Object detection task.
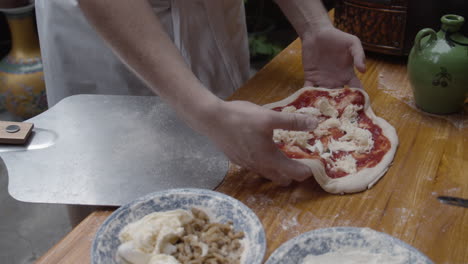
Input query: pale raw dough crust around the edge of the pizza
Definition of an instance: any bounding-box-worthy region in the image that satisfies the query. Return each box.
[264,87,398,193]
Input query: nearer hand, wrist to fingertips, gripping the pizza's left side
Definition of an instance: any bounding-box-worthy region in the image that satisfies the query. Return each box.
[190,101,317,185]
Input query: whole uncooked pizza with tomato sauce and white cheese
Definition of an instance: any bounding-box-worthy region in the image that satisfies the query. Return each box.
[264,87,398,193]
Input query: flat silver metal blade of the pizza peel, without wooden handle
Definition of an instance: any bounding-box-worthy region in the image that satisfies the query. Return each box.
[0,95,228,206]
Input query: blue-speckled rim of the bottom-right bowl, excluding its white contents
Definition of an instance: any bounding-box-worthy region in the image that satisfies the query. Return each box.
[265,227,433,264]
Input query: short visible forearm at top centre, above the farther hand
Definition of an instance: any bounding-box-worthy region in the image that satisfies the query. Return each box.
[275,0,333,39]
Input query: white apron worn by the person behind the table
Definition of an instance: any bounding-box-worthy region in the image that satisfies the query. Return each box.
[36,0,249,106]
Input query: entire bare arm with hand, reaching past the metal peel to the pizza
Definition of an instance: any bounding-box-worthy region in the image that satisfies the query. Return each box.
[79,0,317,184]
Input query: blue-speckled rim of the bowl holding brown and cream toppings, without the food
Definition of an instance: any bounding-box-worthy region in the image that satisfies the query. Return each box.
[91,189,266,264]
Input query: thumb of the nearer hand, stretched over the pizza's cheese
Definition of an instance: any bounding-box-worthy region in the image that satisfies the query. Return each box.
[271,112,318,131]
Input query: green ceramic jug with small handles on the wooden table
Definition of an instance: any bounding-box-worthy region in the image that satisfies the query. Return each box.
[408,15,468,114]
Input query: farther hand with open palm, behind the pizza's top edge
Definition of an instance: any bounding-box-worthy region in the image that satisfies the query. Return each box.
[302,25,366,88]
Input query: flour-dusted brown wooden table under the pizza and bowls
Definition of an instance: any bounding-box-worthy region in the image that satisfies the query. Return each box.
[38,40,468,264]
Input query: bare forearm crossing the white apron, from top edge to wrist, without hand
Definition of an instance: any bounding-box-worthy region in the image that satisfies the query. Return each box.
[79,0,219,118]
